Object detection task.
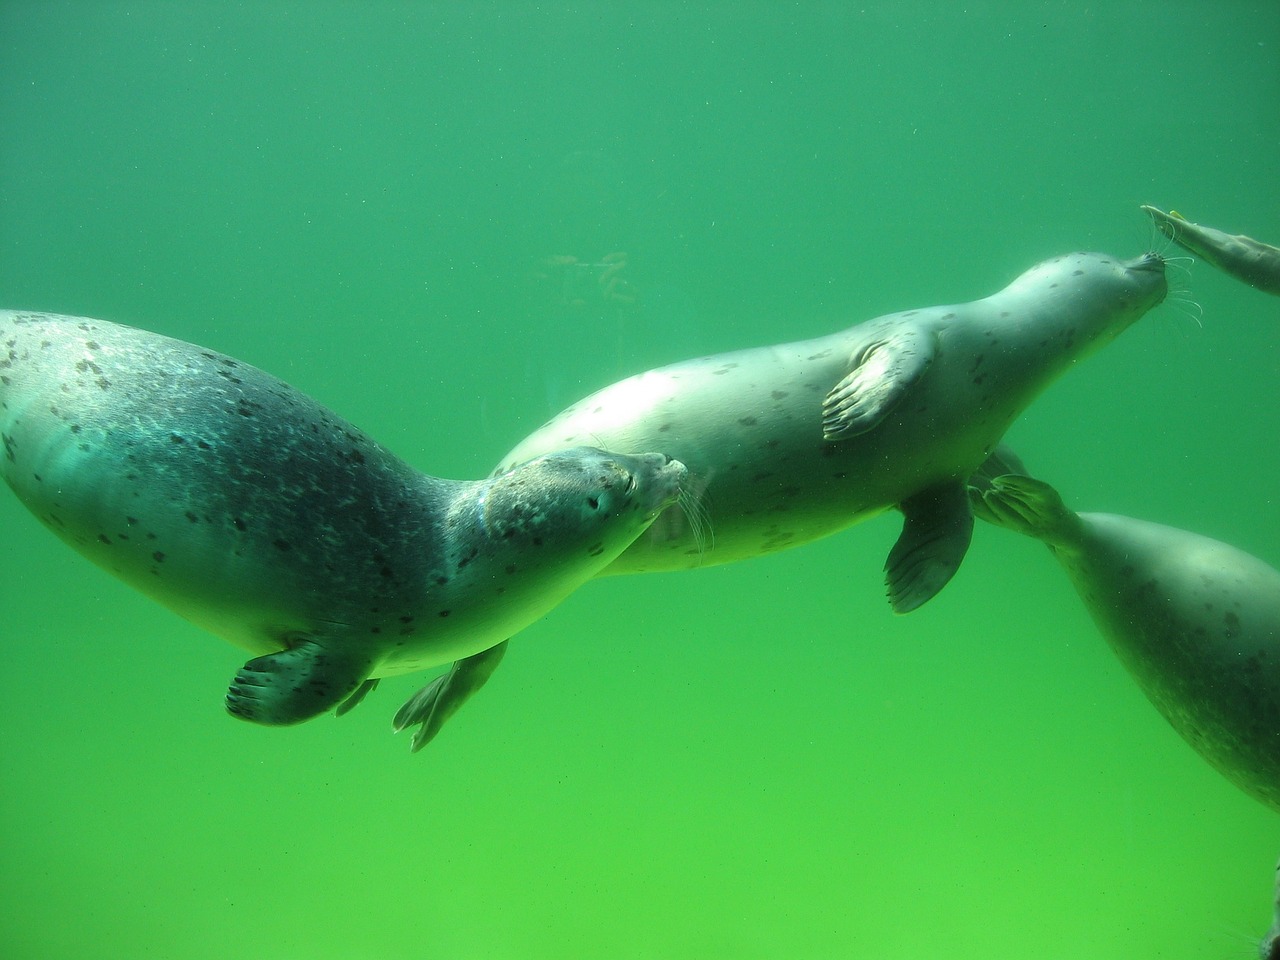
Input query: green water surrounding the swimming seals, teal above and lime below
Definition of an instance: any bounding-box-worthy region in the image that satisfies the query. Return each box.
[0,0,1280,960]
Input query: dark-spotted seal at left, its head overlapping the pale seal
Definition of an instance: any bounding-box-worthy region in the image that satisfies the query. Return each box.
[0,311,685,747]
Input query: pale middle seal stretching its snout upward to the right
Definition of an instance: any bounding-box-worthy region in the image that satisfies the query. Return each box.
[499,253,1166,612]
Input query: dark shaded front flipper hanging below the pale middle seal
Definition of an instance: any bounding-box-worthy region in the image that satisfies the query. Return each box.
[884,480,973,613]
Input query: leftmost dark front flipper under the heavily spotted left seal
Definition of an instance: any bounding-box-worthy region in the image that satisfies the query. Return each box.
[227,640,374,726]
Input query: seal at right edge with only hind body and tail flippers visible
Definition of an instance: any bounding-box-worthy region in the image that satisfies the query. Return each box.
[972,451,1280,810]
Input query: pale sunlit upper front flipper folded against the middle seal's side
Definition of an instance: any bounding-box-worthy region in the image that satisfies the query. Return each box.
[822,326,934,440]
